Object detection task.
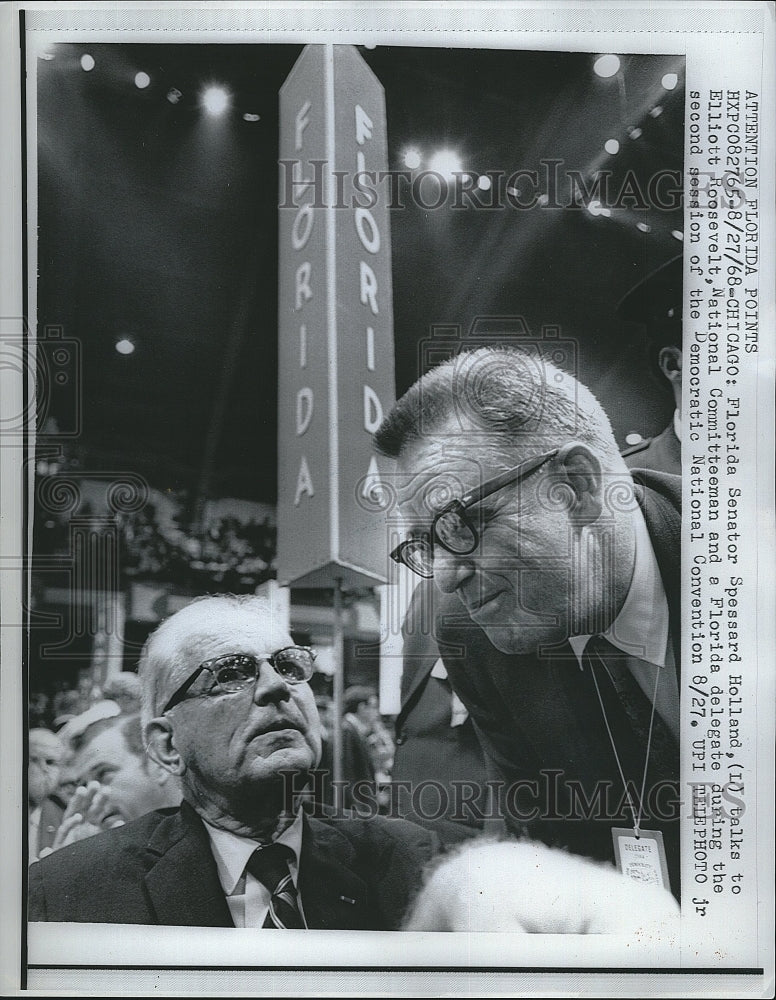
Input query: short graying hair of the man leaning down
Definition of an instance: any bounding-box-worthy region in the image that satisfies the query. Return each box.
[374,347,622,468]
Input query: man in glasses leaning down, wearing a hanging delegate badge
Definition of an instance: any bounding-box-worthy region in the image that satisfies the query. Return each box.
[375,342,681,895]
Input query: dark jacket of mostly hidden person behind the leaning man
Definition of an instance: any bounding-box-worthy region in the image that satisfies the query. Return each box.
[391,580,489,844]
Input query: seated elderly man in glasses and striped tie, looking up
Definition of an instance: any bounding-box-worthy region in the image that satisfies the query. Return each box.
[29,596,437,930]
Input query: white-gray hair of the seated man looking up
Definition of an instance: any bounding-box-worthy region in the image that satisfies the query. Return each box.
[138,594,273,730]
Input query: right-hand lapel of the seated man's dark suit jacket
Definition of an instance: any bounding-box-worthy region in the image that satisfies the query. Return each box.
[299,816,375,930]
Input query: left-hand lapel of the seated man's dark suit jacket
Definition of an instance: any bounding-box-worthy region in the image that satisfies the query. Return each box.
[145,802,234,927]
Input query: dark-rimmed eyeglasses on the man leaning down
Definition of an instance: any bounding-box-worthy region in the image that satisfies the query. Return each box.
[391,448,558,579]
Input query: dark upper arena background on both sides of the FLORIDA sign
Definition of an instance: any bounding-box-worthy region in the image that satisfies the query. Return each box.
[30,43,684,503]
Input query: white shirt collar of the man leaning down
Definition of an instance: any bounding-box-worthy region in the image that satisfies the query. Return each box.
[569,511,669,667]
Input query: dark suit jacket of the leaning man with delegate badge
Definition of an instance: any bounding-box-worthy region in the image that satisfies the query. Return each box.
[437,470,681,889]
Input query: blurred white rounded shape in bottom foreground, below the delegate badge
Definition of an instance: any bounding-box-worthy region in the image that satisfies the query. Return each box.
[403,838,680,941]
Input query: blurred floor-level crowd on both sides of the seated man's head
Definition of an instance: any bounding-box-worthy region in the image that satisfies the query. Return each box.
[28,670,395,863]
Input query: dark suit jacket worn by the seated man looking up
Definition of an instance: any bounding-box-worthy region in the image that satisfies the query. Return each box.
[29,803,438,930]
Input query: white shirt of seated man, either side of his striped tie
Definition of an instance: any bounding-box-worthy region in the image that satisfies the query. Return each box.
[205,810,307,927]
